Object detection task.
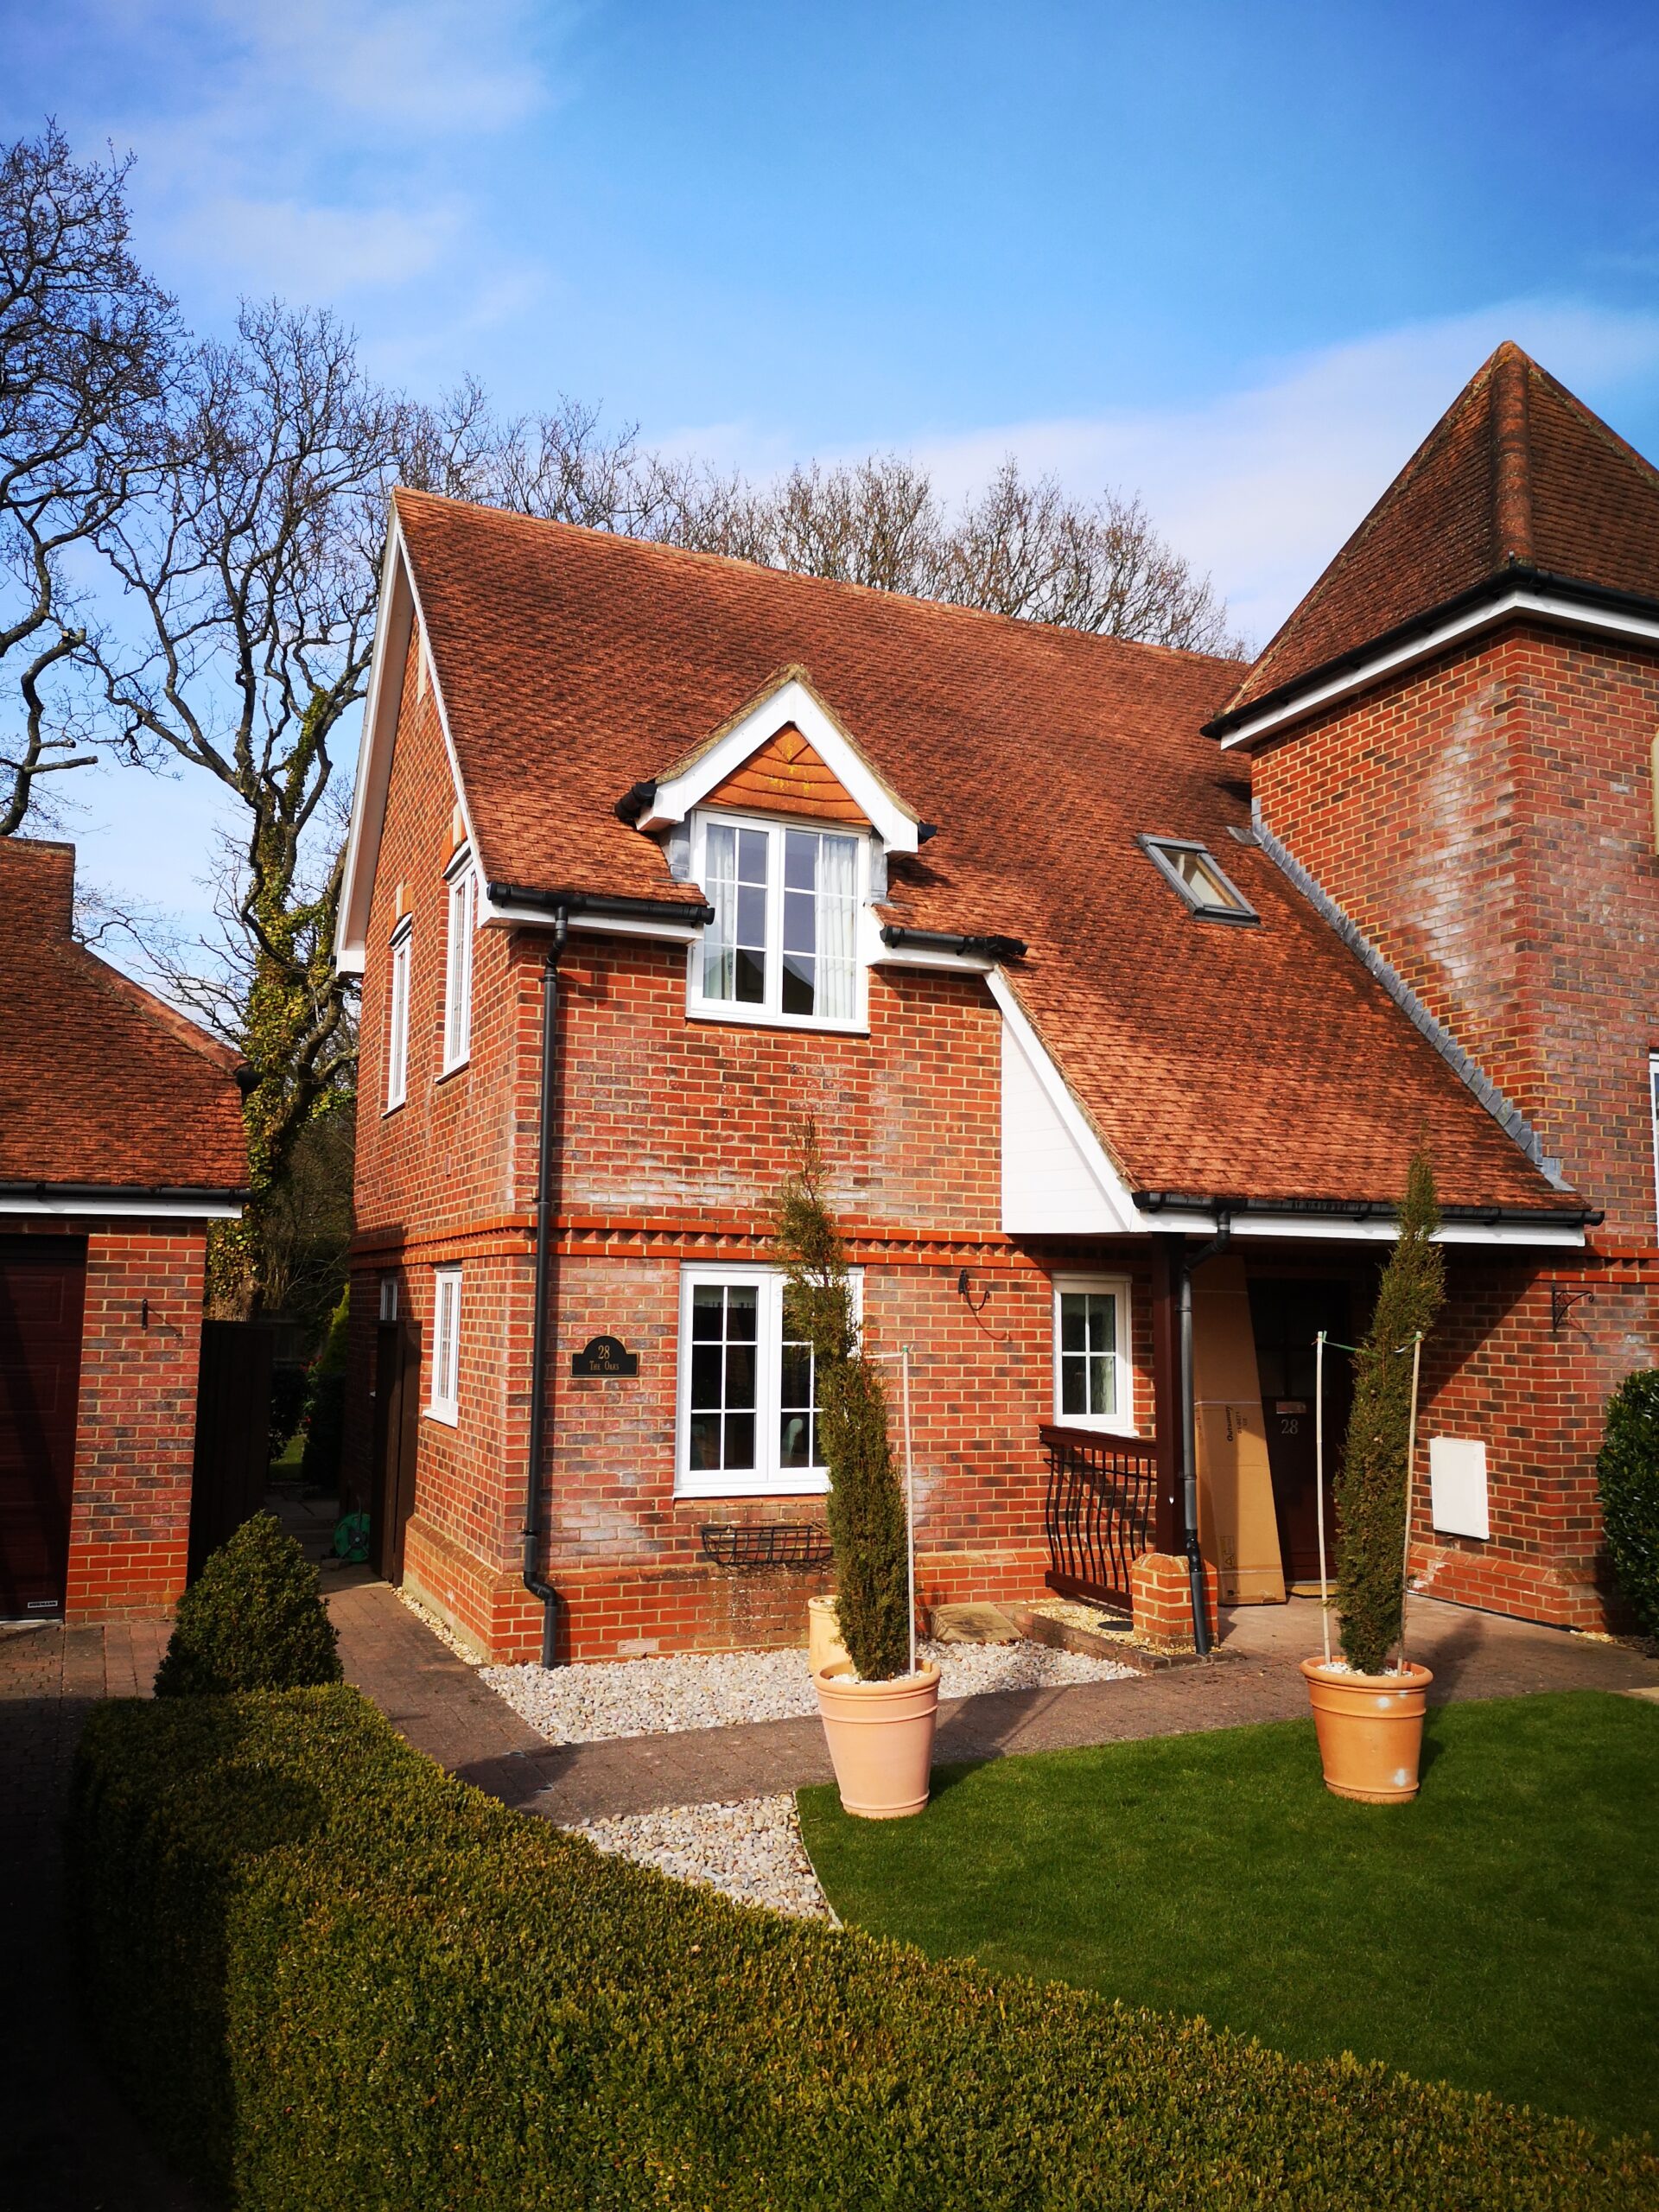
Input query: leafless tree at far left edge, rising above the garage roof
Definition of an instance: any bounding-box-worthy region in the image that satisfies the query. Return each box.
[0,124,175,836]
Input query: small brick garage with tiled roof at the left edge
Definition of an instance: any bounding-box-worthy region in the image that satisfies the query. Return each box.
[0,838,248,1621]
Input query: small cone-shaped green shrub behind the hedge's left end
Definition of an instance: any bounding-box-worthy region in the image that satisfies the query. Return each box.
[155,1513,343,1697]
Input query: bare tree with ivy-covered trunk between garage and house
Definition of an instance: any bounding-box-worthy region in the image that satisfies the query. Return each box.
[98,305,435,1312]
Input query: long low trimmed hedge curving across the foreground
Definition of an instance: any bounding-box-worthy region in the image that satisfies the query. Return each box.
[71,1690,1659,2212]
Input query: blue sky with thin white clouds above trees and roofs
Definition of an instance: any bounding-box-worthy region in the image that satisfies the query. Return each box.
[0,0,1659,925]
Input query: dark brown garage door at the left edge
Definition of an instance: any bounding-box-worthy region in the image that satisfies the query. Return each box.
[0,1236,86,1621]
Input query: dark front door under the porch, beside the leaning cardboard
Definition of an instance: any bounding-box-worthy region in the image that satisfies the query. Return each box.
[1249,1276,1354,1584]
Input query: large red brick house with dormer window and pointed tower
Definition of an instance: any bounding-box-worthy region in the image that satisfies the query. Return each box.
[340,347,1659,1656]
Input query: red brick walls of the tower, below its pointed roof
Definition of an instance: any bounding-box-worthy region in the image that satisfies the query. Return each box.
[1255,626,1659,1626]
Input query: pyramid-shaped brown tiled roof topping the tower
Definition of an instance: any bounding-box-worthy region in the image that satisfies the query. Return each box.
[1225,343,1659,715]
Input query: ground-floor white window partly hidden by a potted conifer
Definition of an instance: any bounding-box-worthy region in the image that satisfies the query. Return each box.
[675,1265,858,1497]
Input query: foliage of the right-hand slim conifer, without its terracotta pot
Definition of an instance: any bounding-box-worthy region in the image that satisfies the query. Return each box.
[1336,1153,1446,1675]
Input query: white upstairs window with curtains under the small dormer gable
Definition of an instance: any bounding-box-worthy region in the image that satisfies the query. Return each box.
[690,814,869,1028]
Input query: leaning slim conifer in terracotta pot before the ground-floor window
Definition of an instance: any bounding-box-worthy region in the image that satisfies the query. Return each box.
[777,1123,938,1821]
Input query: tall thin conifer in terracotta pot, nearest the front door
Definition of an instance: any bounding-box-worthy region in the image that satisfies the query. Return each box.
[1303,1153,1446,1805]
